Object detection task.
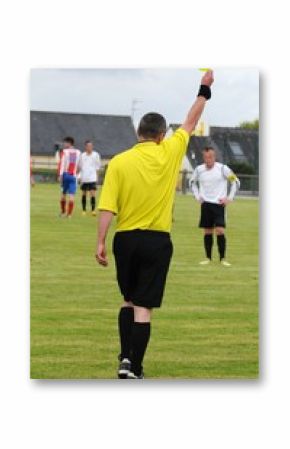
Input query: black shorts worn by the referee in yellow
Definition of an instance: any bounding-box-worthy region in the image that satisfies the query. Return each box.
[113,229,173,309]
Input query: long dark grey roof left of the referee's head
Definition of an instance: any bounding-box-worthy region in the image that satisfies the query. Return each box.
[30,111,137,158]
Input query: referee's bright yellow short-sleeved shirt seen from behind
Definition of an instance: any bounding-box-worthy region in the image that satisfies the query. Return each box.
[98,128,189,232]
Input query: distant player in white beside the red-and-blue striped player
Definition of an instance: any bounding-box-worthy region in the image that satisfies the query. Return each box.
[80,140,101,215]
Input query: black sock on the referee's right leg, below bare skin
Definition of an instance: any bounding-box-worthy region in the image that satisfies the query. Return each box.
[132,323,151,376]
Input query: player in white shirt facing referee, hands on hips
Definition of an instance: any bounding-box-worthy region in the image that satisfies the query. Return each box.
[190,147,240,267]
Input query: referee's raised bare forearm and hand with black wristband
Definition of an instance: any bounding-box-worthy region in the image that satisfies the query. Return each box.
[181,70,214,134]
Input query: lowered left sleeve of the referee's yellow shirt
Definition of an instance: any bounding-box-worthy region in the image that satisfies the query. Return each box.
[98,159,119,214]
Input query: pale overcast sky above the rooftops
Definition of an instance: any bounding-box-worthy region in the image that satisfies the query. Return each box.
[30,68,259,126]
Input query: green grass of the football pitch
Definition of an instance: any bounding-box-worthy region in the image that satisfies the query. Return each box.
[31,184,259,379]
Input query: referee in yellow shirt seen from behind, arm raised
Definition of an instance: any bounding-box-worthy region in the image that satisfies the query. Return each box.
[96,70,213,379]
